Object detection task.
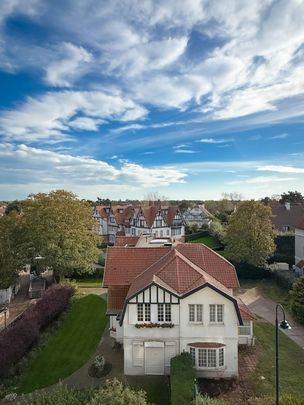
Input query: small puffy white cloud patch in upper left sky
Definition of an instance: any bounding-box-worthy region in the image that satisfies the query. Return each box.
[45,42,93,87]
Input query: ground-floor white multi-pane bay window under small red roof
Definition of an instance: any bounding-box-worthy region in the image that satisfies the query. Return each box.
[190,347,225,368]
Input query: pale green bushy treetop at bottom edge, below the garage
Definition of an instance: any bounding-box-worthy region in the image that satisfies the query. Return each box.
[88,378,148,405]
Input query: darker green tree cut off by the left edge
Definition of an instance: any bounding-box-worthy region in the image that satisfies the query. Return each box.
[0,212,25,289]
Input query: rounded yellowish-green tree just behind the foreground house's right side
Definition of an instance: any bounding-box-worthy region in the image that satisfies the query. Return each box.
[225,200,275,266]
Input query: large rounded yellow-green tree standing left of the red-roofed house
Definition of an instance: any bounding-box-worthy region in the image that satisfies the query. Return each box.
[22,190,99,279]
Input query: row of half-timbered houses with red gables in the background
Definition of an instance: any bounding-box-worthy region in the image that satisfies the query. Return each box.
[94,203,185,243]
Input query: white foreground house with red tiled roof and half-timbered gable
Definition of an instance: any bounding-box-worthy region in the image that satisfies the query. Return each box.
[104,241,255,378]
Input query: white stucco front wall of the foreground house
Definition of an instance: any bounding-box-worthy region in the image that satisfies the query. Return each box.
[123,287,239,378]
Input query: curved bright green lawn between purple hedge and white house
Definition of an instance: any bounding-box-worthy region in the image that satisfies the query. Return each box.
[17,294,107,393]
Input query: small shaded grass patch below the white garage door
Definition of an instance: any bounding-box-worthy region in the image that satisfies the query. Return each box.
[127,376,170,405]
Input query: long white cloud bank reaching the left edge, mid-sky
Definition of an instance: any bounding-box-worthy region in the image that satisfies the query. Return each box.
[0,91,146,142]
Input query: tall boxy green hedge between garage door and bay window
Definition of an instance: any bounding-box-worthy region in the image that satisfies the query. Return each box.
[170,352,196,405]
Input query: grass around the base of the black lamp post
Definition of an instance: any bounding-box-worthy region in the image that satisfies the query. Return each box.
[253,321,304,397]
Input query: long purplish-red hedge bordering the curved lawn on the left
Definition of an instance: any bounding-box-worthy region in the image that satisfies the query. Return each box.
[0,285,73,376]
